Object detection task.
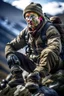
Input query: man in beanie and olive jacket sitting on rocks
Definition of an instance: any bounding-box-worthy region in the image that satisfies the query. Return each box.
[5,2,62,95]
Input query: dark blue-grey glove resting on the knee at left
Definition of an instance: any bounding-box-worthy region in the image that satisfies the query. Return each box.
[7,54,23,73]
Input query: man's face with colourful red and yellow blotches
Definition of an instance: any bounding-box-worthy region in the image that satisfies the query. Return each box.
[25,12,40,30]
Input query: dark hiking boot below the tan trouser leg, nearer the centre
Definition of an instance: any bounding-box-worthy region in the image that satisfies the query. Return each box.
[25,72,40,92]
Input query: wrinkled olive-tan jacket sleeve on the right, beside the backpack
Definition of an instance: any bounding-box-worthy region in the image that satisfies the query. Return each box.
[46,26,62,55]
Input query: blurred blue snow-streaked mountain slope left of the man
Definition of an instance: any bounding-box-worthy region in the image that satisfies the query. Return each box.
[0,1,26,80]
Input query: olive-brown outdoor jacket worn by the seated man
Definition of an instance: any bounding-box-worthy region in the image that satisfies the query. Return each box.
[5,21,62,74]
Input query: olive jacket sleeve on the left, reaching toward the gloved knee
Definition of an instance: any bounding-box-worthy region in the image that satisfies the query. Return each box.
[5,28,26,57]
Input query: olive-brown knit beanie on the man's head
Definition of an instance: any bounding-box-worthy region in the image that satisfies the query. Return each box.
[23,2,43,17]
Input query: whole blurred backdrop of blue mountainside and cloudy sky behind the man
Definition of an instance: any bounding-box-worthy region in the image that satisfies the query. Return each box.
[0,0,64,81]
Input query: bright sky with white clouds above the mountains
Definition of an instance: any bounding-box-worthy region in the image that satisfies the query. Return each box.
[4,0,64,15]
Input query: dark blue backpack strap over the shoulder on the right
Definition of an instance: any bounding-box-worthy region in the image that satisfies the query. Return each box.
[40,21,53,48]
